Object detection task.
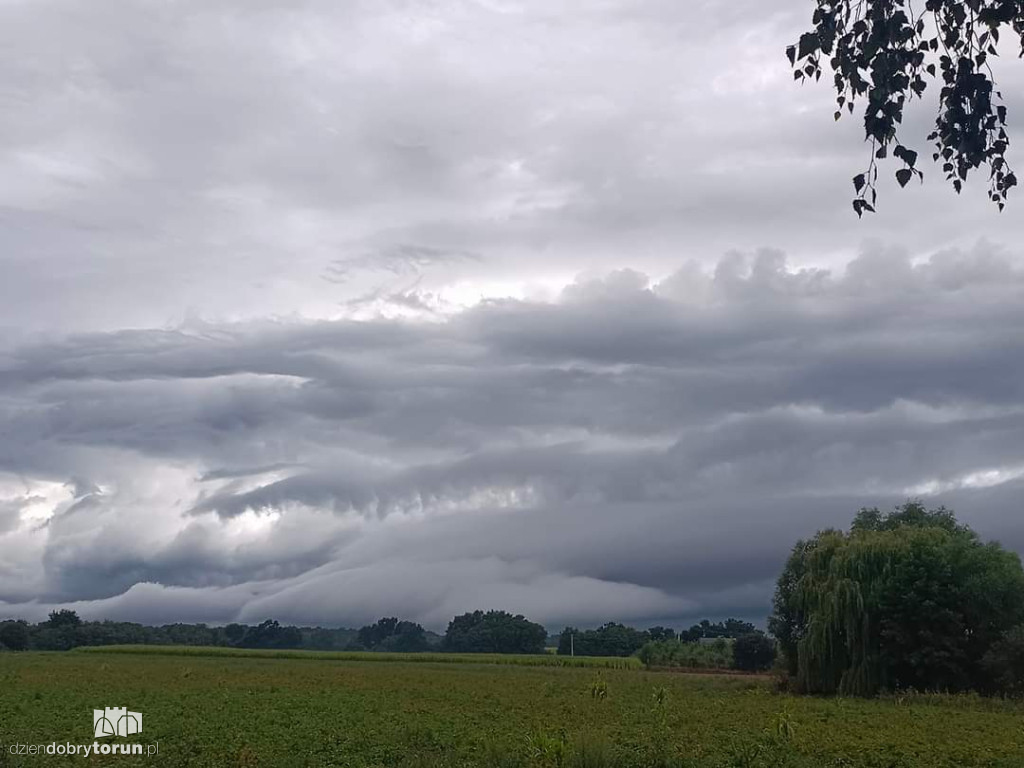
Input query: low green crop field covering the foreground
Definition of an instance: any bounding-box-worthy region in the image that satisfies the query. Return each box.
[0,649,1024,768]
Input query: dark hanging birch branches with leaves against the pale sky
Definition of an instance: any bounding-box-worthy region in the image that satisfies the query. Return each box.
[786,0,1024,211]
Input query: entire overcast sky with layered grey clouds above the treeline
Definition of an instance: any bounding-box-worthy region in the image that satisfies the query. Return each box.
[0,0,1024,630]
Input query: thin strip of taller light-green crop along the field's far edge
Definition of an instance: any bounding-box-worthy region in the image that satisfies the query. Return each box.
[74,645,643,670]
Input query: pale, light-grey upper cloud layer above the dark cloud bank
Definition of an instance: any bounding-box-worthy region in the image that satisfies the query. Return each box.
[0,0,1024,331]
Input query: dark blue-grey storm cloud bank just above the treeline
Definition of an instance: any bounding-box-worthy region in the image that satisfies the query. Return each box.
[0,249,1024,627]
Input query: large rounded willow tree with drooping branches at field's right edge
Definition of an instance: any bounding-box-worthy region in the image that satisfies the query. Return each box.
[769,502,1024,695]
